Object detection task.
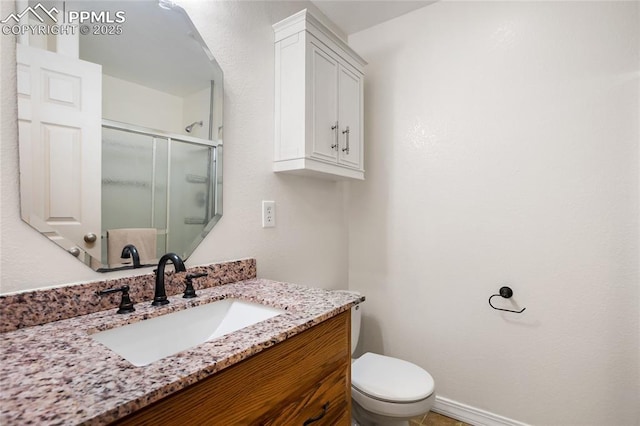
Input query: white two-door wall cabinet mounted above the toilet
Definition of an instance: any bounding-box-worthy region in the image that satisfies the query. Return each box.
[273,10,366,180]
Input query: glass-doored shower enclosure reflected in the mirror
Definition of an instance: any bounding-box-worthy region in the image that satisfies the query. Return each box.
[102,120,222,267]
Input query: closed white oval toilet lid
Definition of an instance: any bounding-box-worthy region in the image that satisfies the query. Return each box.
[351,352,434,402]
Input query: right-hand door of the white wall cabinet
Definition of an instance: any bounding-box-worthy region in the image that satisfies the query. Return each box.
[338,66,362,169]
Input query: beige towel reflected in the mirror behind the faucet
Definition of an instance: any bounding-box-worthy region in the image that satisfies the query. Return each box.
[107,228,158,267]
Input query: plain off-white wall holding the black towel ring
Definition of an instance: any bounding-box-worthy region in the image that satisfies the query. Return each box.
[348,2,640,426]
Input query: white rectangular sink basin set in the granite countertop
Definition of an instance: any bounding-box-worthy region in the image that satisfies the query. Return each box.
[91,299,285,367]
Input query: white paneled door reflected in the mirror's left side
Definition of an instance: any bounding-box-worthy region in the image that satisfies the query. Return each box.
[17,44,102,259]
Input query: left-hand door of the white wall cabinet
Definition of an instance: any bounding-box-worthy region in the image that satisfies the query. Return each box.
[311,44,338,163]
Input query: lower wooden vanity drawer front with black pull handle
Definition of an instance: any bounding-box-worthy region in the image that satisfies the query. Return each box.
[260,370,351,426]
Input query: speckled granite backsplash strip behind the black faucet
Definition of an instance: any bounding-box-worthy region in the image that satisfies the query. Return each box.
[0,259,256,333]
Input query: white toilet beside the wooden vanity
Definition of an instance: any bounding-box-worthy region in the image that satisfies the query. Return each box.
[351,303,436,426]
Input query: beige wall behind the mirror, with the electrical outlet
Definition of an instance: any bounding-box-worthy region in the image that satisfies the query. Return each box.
[0,1,347,293]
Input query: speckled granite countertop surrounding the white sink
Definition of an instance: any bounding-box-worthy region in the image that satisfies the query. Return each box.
[0,279,364,425]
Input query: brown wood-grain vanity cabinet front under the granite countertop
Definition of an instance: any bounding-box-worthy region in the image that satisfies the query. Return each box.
[116,311,351,426]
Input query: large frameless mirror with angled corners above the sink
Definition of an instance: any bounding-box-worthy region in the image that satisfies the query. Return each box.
[16,0,223,272]
